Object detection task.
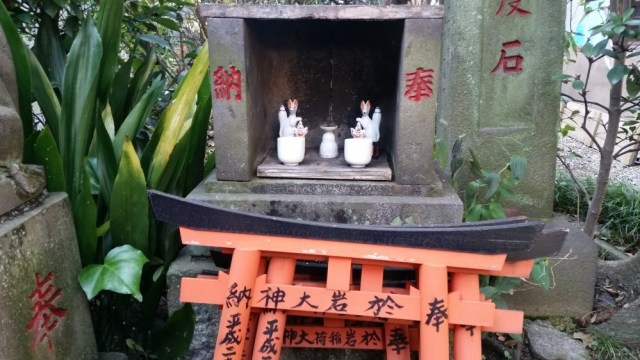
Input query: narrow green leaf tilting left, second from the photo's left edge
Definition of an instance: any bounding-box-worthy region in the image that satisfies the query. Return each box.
[27,50,62,138]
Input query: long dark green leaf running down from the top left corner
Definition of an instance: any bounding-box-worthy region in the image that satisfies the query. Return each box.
[0,2,33,139]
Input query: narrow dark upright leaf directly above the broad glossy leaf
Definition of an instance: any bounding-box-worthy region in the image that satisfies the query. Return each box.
[72,162,98,265]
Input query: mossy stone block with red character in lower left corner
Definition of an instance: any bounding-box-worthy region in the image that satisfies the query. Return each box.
[0,193,98,360]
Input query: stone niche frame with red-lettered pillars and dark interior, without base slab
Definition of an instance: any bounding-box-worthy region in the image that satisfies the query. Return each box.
[208,4,443,185]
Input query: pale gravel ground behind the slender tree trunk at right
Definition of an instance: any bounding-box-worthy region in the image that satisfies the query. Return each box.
[556,137,640,187]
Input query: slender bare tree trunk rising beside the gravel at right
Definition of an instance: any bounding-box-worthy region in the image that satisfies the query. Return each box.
[583,1,627,237]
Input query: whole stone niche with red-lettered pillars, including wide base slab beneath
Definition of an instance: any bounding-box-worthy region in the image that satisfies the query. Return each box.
[195,4,462,224]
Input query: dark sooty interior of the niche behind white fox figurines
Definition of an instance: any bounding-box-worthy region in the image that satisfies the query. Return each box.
[245,19,404,158]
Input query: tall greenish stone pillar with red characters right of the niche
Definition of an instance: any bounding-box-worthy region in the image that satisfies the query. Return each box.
[437,0,566,218]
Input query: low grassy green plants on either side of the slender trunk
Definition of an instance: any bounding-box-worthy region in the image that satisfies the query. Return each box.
[554,171,640,251]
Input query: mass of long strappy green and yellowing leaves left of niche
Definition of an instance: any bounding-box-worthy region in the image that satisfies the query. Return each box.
[0,0,215,359]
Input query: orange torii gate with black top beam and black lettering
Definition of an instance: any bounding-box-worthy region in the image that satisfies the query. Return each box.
[151,193,566,360]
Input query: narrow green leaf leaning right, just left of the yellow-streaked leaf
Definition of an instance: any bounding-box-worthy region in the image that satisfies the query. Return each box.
[113,77,165,161]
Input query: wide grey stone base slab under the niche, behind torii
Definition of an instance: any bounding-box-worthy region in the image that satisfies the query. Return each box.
[187,166,463,225]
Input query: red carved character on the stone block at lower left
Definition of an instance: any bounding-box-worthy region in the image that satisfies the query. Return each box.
[27,273,67,352]
